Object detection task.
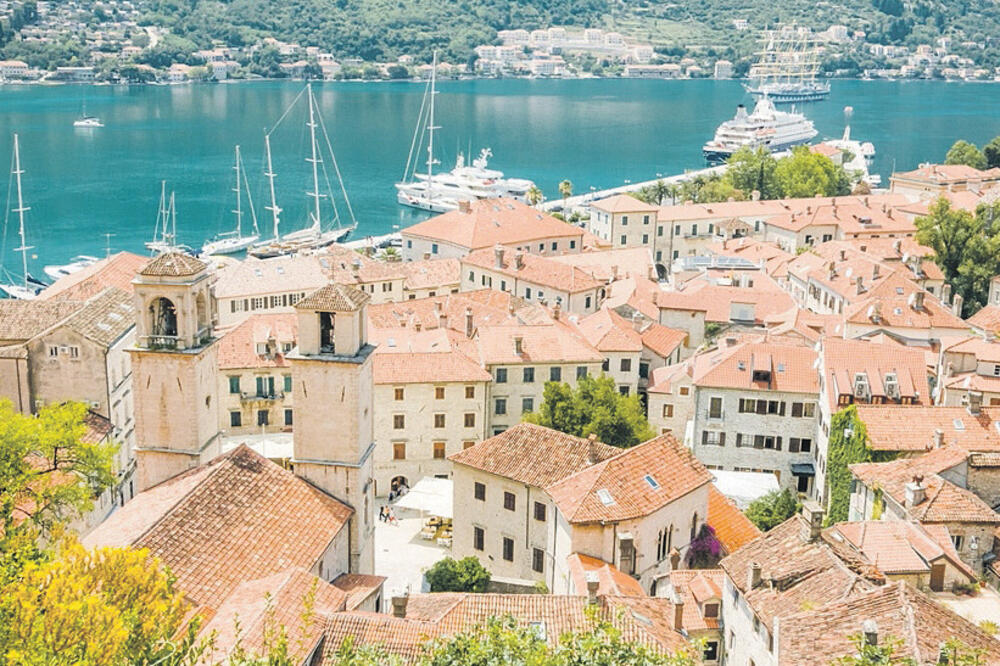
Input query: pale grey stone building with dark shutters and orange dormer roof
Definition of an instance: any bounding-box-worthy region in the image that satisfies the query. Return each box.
[687,339,819,494]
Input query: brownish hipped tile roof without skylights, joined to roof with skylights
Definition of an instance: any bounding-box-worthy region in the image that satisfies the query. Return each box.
[448,423,621,488]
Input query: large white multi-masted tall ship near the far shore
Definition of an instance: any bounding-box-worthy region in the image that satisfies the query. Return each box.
[744,26,830,104]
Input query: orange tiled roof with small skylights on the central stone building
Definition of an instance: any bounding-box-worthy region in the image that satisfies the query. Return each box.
[546,434,712,523]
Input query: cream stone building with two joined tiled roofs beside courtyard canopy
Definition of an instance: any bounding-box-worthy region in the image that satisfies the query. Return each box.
[451,423,711,594]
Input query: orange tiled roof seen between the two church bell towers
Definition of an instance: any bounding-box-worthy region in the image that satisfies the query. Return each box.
[218,312,299,370]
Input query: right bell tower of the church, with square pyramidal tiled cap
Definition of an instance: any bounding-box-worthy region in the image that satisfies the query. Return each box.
[288,284,375,573]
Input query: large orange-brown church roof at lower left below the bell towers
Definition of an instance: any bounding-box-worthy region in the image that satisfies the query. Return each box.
[83,445,353,608]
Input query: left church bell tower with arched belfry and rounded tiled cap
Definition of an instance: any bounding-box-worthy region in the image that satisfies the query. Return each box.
[129,253,220,491]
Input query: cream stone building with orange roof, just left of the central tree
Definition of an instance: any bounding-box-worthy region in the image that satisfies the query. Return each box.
[473,321,604,435]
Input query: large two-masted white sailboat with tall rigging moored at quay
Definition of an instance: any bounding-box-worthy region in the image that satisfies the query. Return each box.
[247,84,358,259]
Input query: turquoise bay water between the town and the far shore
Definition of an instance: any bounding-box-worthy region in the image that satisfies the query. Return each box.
[0,79,1000,276]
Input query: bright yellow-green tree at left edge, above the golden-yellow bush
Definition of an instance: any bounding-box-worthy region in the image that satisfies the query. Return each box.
[0,400,116,536]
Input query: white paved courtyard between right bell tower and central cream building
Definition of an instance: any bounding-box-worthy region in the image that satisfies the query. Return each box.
[375,499,451,598]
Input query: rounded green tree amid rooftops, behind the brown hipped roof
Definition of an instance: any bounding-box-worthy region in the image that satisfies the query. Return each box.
[524,375,655,448]
